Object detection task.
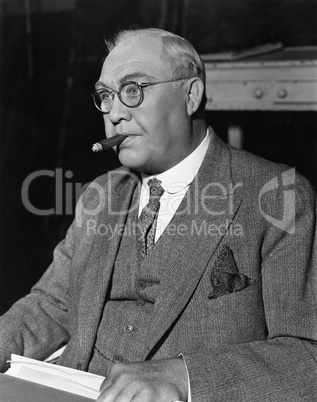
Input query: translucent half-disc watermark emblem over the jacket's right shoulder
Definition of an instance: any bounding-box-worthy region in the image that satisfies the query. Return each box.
[259,168,295,234]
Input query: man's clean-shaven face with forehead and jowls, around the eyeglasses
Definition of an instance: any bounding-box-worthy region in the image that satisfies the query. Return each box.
[96,35,196,174]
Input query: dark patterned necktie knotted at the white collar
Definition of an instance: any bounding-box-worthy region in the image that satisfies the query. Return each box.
[137,177,164,260]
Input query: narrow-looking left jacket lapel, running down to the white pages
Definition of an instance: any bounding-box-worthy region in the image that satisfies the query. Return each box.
[76,171,140,369]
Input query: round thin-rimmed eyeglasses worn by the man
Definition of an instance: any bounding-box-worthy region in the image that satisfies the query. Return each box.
[92,78,186,113]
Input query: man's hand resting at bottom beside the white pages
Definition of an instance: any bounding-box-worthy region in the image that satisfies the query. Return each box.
[97,358,188,402]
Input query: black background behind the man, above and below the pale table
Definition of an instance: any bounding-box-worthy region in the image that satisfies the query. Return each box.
[0,0,317,313]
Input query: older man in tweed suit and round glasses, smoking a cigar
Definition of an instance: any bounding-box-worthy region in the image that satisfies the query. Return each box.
[0,29,317,402]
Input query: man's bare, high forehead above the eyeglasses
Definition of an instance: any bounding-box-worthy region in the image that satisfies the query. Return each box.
[100,35,172,85]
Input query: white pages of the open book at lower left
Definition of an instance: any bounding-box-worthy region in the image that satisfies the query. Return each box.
[5,354,105,400]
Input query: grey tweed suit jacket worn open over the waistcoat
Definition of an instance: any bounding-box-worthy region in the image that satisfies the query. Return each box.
[0,133,317,402]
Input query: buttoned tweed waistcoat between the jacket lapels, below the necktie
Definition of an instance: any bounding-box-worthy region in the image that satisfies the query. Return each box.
[88,192,166,376]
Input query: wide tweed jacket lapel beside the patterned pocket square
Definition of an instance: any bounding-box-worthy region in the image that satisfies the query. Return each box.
[146,133,242,356]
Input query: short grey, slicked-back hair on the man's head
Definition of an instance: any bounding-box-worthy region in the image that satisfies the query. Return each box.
[106,28,206,110]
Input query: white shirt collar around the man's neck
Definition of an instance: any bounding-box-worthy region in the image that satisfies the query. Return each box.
[141,129,210,194]
